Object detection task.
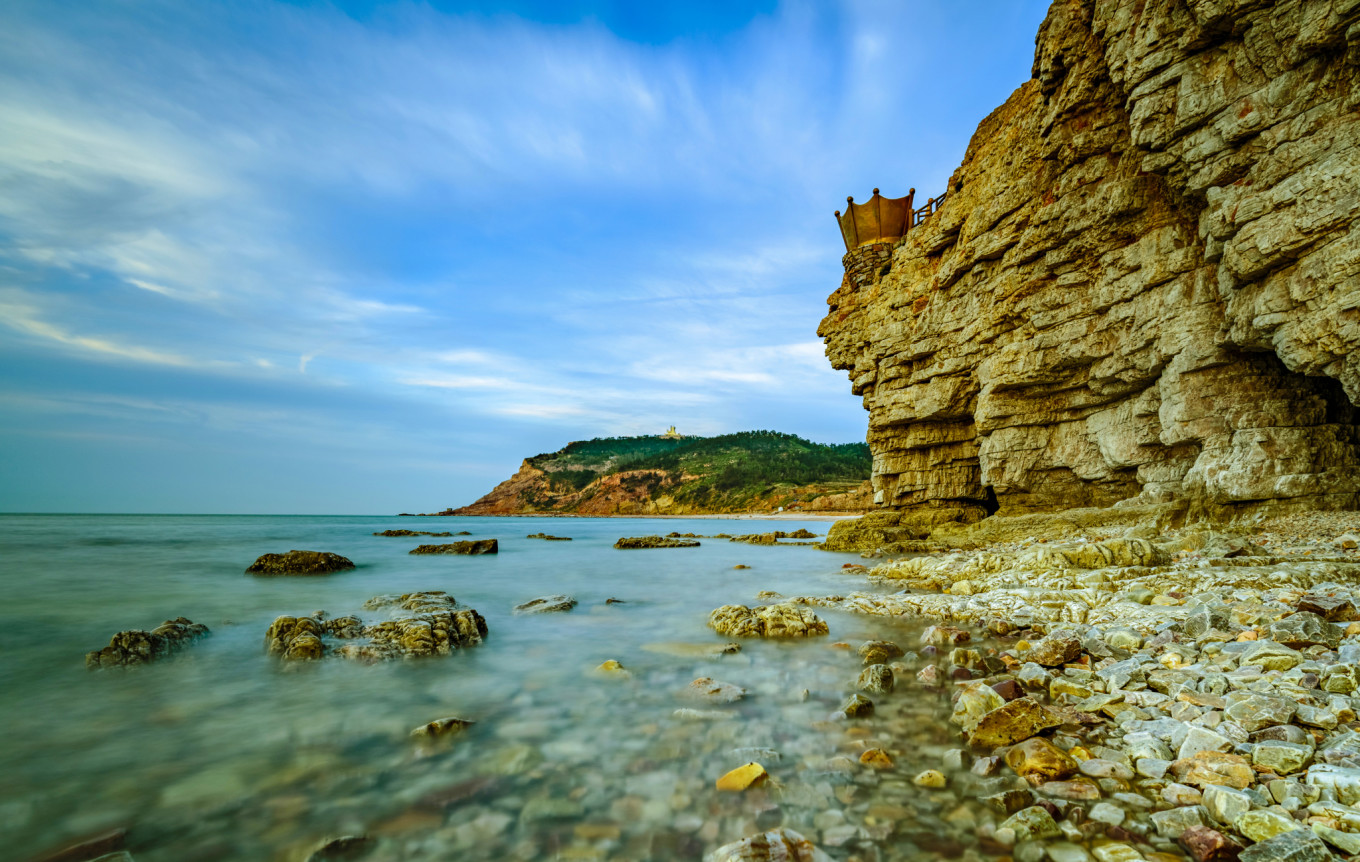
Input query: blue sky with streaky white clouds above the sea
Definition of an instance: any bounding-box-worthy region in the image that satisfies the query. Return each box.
[0,0,1047,514]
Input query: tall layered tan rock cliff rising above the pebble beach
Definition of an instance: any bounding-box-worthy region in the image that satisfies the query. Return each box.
[819,0,1360,528]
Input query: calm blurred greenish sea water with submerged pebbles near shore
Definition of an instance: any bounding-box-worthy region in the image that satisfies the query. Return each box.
[0,515,989,862]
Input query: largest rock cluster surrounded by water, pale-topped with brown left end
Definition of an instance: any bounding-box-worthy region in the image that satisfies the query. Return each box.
[264,590,487,662]
